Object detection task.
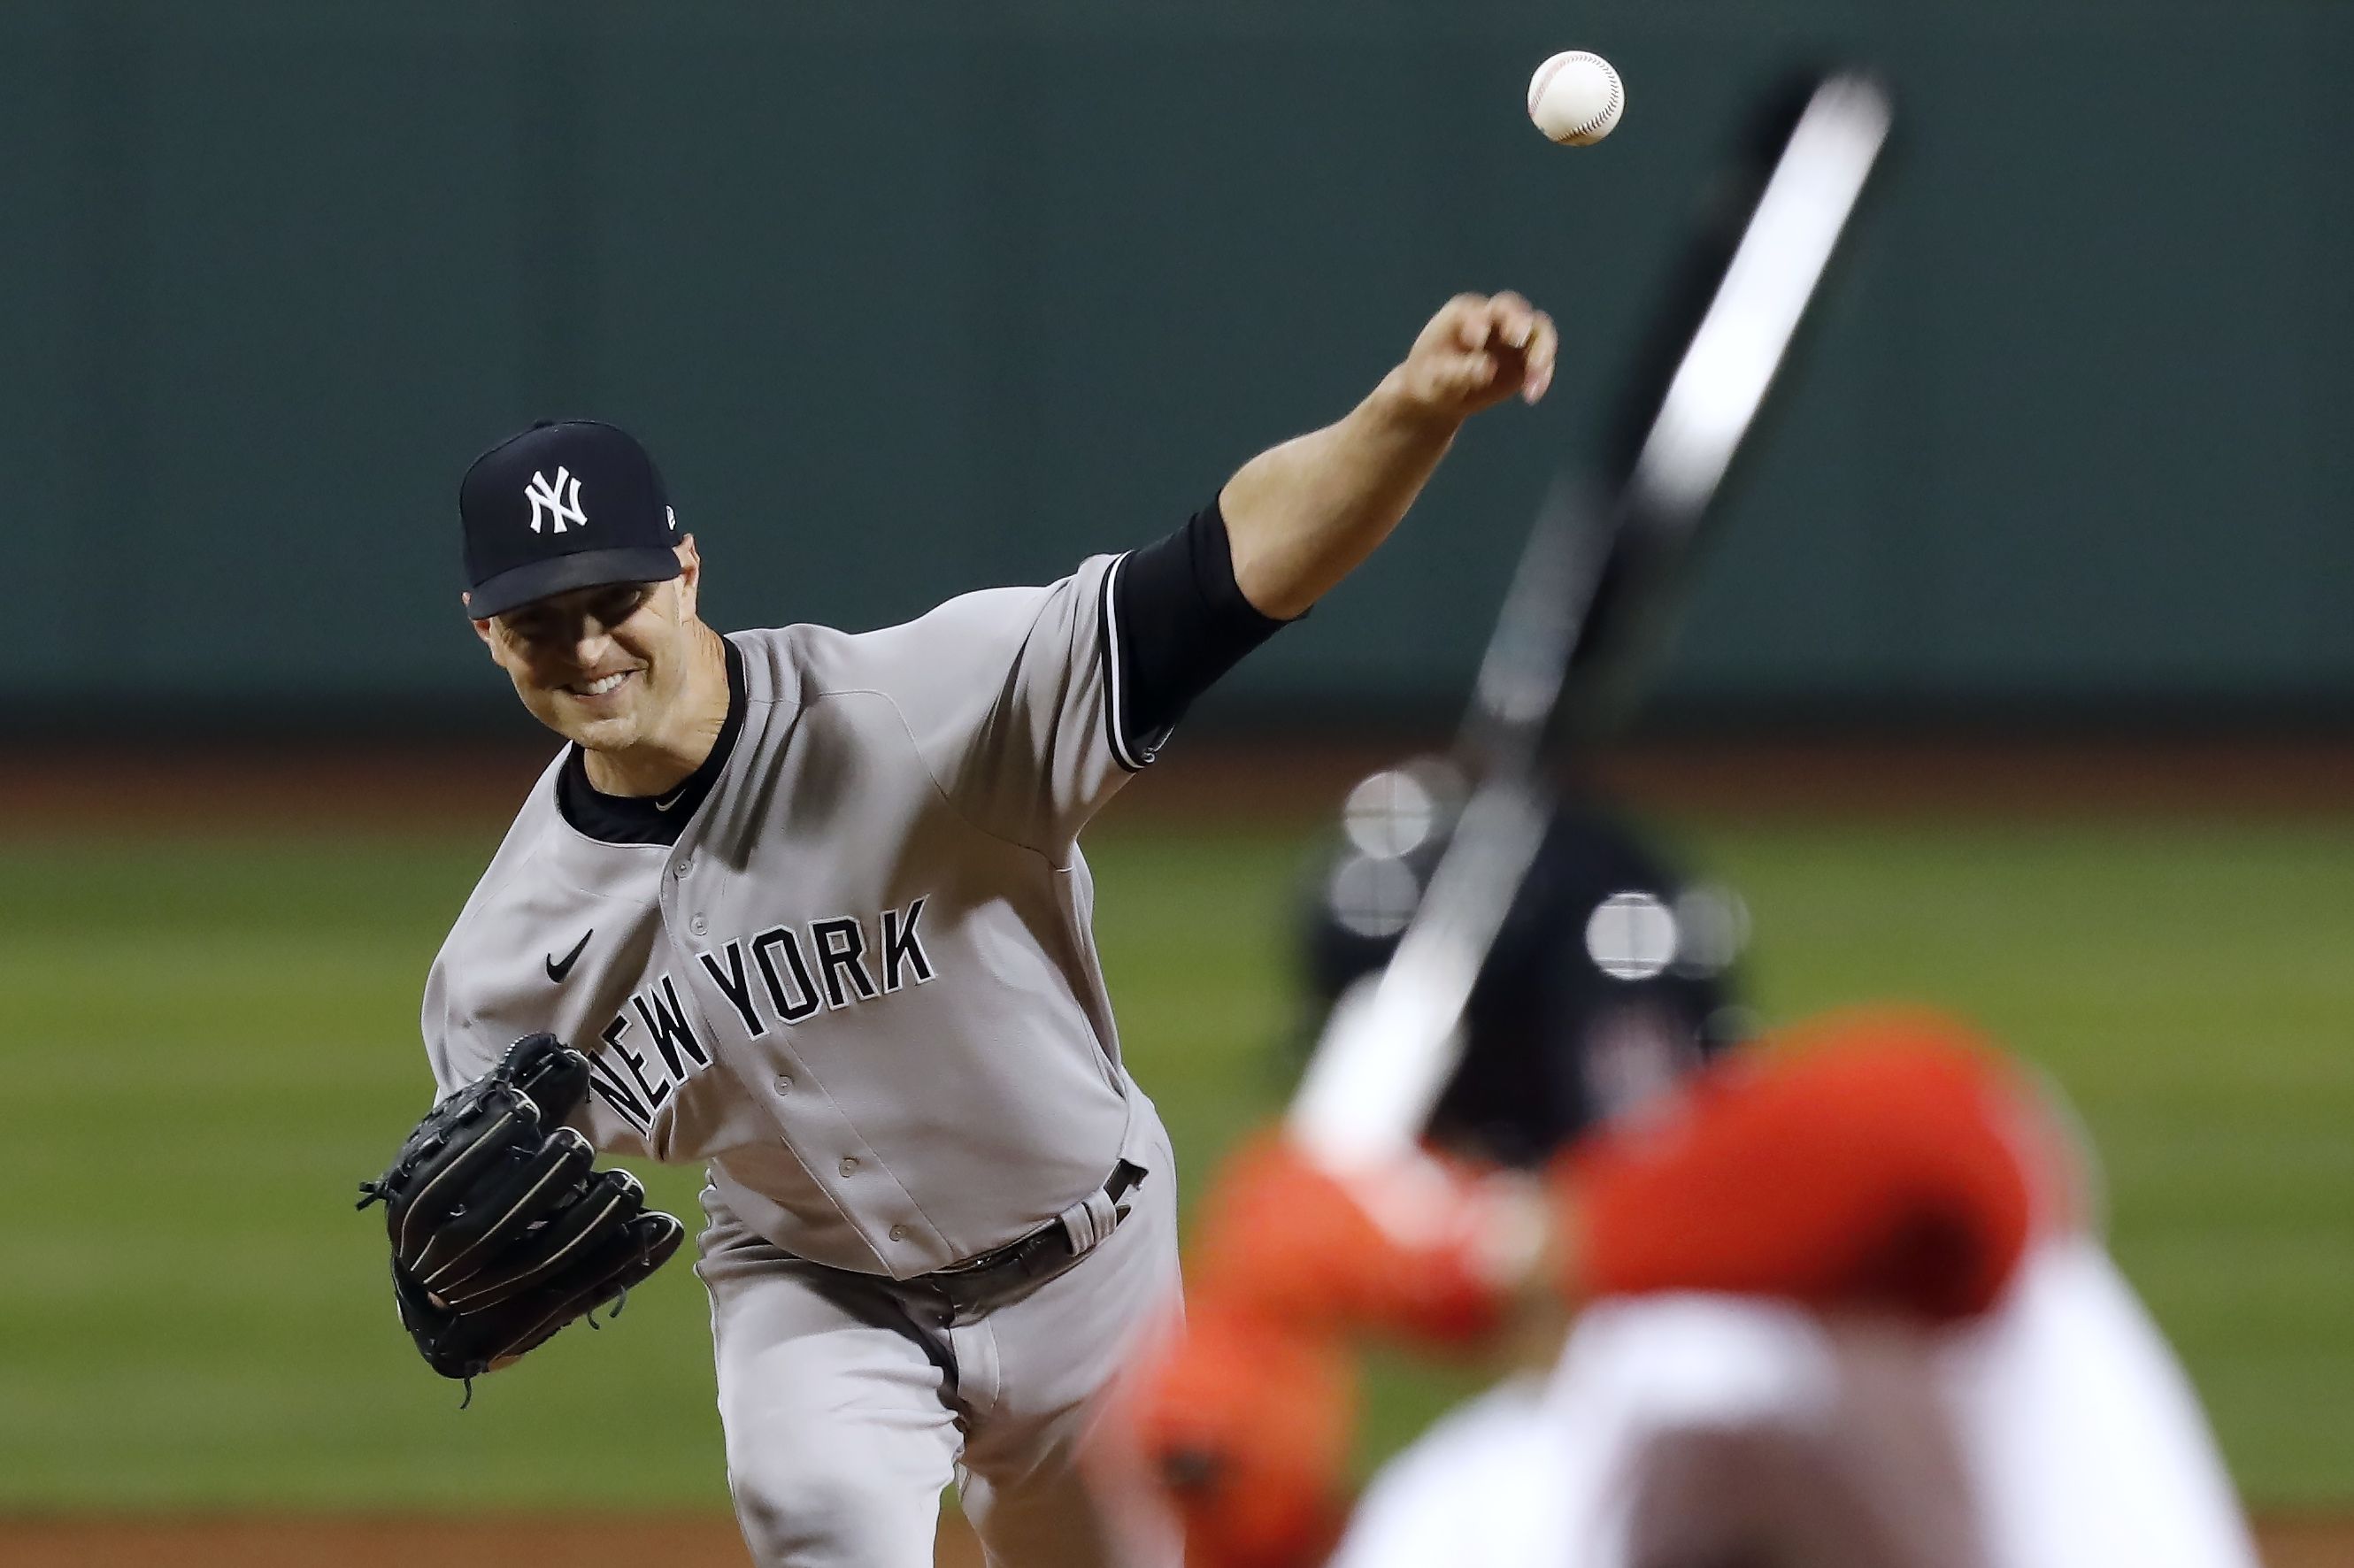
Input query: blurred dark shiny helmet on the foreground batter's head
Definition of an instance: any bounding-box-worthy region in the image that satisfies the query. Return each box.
[1304,763,1747,1165]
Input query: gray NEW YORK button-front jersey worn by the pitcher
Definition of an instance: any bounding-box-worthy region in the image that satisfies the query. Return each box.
[424,556,1151,1279]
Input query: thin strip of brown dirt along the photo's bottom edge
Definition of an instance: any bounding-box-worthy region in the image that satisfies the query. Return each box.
[0,1514,2354,1568]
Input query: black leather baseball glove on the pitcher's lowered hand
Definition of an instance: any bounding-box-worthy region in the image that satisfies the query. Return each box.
[360,1034,685,1380]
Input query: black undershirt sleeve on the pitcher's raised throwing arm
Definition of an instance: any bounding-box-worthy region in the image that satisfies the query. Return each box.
[1112,502,1290,760]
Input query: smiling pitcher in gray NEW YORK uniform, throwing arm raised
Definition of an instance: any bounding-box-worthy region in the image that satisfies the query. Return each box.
[358,295,1556,1568]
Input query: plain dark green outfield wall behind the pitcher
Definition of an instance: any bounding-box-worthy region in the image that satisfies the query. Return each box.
[0,0,2354,725]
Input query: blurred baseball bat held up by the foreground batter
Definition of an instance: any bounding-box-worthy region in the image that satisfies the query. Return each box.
[1288,73,1890,1170]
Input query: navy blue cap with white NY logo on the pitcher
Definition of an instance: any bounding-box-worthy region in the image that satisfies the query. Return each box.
[457,419,681,621]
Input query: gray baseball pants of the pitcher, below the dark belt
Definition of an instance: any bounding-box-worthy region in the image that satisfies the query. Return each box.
[696,1111,1181,1568]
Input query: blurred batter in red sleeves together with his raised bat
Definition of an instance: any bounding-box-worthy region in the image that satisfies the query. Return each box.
[1104,73,2253,1568]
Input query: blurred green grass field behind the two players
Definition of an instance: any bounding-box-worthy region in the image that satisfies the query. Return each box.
[0,822,2354,1511]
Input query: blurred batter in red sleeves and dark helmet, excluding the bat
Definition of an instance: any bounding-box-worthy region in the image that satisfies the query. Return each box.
[1109,777,2255,1568]
